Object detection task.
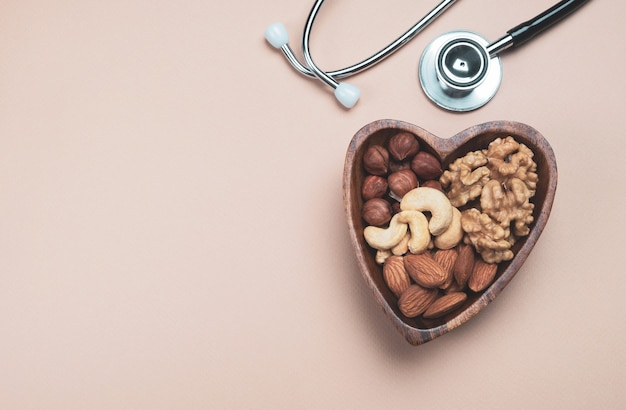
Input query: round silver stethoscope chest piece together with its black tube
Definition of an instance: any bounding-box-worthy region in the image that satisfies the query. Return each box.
[418,0,588,112]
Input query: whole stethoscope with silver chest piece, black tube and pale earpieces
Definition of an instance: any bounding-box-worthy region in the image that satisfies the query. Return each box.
[265,0,588,111]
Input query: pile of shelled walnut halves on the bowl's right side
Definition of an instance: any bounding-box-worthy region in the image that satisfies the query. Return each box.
[440,136,539,263]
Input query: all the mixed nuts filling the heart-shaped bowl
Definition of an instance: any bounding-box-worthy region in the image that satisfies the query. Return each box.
[361,132,538,319]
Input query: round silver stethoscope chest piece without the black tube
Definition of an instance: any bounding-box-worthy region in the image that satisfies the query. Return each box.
[419,31,502,112]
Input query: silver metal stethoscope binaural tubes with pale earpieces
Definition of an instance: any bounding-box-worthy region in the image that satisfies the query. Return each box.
[265,0,456,108]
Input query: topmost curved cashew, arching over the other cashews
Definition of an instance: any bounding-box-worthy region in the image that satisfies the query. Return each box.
[400,187,454,236]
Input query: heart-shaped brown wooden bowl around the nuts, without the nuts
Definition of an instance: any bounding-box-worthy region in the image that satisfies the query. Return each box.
[343,120,557,345]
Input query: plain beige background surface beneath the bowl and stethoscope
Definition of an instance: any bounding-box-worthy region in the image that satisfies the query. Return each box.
[0,0,626,409]
